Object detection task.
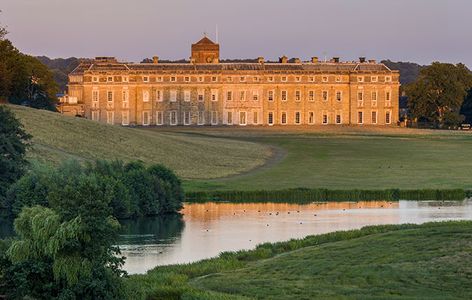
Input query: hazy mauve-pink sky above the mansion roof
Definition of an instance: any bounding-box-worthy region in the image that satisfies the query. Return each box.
[0,0,472,67]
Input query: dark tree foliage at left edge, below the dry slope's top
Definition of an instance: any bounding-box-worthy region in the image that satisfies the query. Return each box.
[0,105,30,204]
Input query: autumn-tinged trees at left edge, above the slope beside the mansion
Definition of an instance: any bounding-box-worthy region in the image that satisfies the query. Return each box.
[0,38,57,110]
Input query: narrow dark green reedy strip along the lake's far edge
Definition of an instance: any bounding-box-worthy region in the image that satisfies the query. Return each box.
[185,188,472,204]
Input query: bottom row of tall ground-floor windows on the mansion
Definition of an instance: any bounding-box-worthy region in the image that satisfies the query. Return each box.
[92,110,392,126]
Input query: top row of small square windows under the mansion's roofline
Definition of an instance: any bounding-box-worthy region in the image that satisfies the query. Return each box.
[92,76,392,83]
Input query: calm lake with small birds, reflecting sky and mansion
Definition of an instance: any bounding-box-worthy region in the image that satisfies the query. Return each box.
[119,200,472,274]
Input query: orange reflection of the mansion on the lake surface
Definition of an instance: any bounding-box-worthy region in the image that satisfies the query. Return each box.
[181,201,399,222]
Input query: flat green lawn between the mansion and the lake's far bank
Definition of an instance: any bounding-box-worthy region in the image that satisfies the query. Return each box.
[174,128,472,191]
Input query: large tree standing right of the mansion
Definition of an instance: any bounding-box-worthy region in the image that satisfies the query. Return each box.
[406,62,472,127]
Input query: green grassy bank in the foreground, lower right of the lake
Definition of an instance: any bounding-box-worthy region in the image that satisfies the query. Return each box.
[126,221,472,299]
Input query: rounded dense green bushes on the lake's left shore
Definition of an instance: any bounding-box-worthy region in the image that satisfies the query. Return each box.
[5,161,184,218]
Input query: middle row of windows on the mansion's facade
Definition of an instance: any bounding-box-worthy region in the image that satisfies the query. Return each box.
[92,90,391,107]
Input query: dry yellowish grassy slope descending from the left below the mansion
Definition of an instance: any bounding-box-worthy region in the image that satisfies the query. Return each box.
[10,106,270,179]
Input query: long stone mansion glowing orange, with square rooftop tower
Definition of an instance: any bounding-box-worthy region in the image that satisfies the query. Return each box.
[59,37,400,126]
